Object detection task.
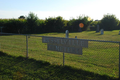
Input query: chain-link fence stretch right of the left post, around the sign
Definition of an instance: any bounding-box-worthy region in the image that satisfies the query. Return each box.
[28,36,119,77]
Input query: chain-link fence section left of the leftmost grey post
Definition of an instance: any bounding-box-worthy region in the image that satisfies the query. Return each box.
[0,35,26,56]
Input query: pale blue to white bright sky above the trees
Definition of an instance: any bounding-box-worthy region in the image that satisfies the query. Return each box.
[0,0,120,20]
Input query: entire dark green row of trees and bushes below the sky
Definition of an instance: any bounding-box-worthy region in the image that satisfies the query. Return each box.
[0,12,120,34]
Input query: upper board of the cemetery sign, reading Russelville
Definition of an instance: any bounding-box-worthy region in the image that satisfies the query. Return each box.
[42,37,88,48]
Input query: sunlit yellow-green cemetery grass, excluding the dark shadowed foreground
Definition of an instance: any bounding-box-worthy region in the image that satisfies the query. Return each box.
[0,30,120,79]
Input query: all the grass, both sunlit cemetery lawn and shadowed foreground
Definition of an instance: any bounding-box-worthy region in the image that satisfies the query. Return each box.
[0,30,120,80]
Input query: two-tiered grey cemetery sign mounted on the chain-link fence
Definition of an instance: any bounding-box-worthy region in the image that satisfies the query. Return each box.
[42,37,88,55]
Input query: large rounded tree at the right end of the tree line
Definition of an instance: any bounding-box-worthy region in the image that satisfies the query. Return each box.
[100,14,119,30]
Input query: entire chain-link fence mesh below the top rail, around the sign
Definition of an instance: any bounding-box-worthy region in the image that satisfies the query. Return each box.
[0,34,120,77]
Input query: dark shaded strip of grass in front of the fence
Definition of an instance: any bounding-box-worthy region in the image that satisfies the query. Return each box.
[0,51,119,80]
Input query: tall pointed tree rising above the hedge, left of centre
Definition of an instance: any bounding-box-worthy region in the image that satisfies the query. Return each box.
[26,12,38,33]
